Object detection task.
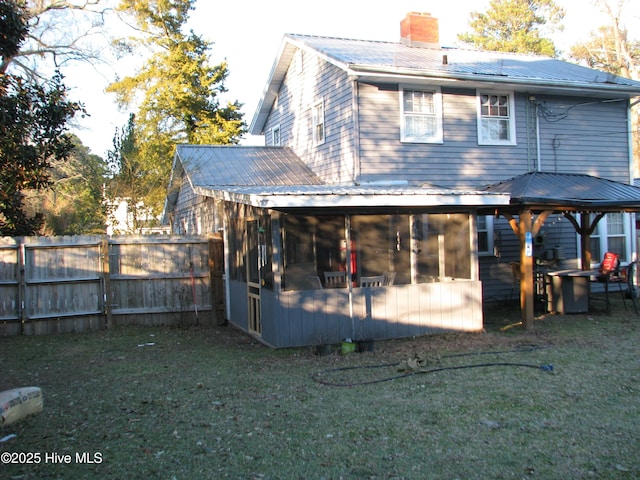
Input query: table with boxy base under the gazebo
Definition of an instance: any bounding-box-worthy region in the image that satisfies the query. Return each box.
[547,269,598,313]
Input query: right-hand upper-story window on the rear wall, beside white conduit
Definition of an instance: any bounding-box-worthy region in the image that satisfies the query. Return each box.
[478,92,516,145]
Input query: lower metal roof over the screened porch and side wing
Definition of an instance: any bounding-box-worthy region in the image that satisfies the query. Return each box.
[165,145,509,211]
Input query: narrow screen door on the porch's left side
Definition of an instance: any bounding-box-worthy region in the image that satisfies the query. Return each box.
[246,220,266,335]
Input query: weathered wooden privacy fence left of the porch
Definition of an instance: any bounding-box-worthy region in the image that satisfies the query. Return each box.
[0,236,224,335]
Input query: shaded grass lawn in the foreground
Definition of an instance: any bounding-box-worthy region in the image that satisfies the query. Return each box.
[0,296,640,480]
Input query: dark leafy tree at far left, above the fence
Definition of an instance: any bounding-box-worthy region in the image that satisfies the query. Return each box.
[0,0,82,236]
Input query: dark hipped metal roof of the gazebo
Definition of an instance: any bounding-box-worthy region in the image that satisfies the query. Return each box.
[484,172,640,211]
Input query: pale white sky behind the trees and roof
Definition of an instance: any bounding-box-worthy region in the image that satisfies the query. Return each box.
[64,0,640,157]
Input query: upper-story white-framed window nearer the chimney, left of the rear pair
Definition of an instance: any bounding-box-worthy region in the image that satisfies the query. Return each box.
[400,88,442,143]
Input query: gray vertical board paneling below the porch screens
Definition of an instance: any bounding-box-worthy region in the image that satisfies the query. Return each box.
[241,280,482,347]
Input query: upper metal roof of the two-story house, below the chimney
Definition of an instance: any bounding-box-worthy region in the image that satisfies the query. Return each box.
[249,34,640,135]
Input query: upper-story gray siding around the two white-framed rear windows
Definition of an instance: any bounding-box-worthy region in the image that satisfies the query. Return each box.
[358,84,629,187]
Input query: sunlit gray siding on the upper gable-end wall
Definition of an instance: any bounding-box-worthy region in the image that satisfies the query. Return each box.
[264,48,354,183]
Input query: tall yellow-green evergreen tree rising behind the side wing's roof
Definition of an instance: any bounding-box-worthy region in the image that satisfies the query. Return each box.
[108,0,245,214]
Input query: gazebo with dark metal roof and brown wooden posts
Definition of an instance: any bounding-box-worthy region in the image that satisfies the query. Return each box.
[486,172,640,328]
